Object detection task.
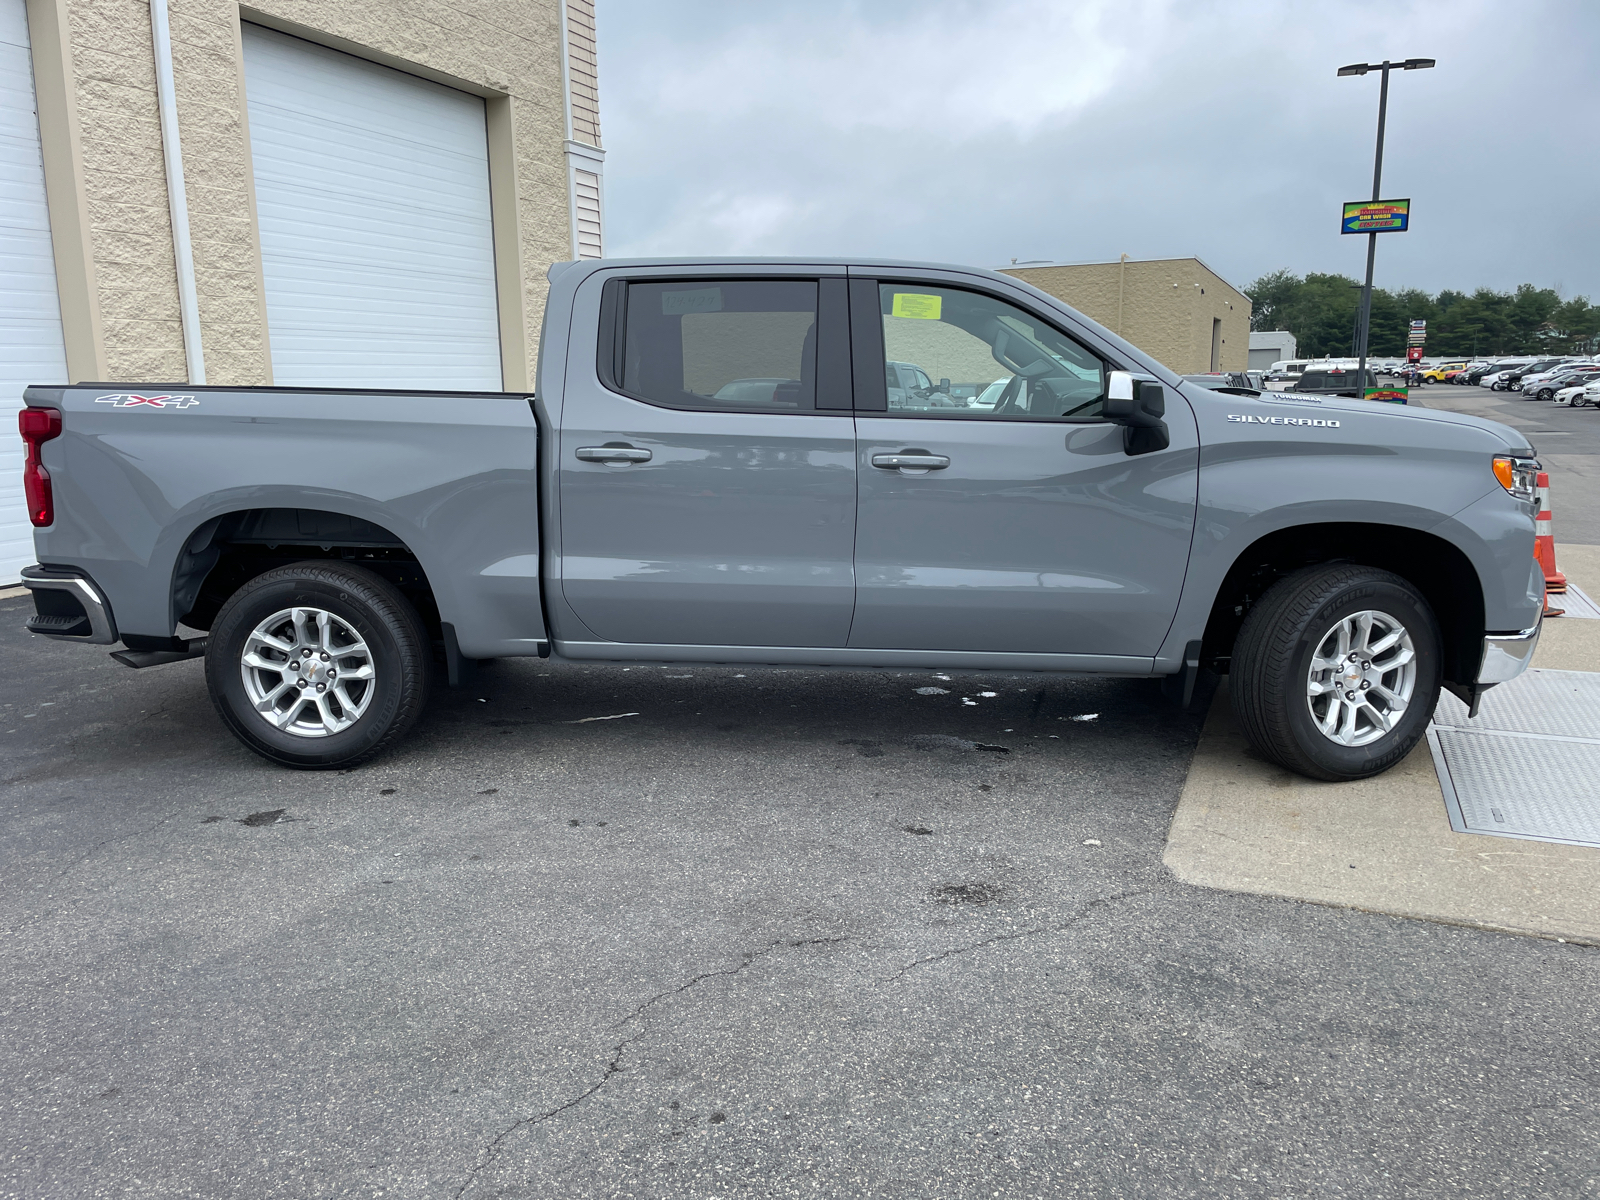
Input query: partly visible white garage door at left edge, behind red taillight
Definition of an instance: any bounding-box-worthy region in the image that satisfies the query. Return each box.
[0,0,67,586]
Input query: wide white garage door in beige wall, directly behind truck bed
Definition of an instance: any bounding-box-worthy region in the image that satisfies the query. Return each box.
[245,24,501,390]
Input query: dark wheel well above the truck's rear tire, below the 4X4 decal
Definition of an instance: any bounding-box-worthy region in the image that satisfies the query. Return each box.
[173,509,443,642]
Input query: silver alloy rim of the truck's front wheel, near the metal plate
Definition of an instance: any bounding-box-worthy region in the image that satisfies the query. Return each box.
[1306,608,1416,747]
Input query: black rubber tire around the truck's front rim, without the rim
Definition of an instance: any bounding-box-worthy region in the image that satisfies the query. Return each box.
[1229,563,1440,781]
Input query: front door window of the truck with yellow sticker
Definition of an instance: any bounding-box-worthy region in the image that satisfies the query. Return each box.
[876,283,1106,421]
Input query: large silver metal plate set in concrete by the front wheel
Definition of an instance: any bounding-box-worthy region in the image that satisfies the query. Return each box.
[1427,670,1600,846]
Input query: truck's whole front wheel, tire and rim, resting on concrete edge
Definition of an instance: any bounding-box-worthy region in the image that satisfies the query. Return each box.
[1230,565,1440,781]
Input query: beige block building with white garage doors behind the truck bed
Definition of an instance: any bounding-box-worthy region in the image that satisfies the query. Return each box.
[0,0,605,581]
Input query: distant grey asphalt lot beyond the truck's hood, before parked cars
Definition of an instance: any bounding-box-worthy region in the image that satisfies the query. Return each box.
[1410,384,1600,546]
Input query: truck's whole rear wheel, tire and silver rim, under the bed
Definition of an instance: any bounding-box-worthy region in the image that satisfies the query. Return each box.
[205,562,429,768]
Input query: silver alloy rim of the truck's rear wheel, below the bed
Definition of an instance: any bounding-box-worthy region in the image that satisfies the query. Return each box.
[238,606,378,738]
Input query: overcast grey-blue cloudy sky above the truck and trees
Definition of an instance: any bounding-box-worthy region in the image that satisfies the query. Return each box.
[598,0,1600,301]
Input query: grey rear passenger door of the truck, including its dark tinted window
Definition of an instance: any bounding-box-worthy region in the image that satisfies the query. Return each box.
[554,267,857,656]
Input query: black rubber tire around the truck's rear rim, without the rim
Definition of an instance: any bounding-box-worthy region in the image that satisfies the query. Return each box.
[205,560,432,770]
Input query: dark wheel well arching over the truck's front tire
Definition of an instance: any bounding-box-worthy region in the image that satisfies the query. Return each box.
[1200,523,1483,683]
